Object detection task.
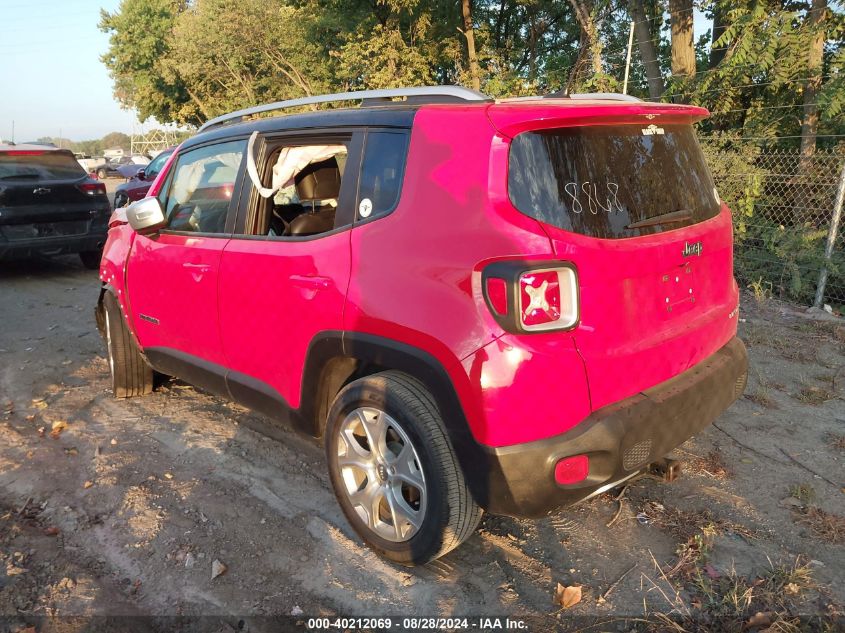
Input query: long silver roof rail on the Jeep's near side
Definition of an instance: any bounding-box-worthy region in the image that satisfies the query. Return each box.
[198,86,490,132]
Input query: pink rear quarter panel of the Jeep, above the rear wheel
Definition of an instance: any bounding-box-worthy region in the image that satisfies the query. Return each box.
[344,106,589,445]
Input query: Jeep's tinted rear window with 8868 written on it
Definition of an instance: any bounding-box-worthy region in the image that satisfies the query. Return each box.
[508,125,720,238]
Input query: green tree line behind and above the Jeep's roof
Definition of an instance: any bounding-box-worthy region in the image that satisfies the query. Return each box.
[99,0,845,155]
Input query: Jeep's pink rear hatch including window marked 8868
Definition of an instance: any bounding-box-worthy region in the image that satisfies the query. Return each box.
[494,105,737,410]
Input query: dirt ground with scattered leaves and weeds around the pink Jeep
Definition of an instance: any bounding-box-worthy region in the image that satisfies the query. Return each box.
[0,252,845,632]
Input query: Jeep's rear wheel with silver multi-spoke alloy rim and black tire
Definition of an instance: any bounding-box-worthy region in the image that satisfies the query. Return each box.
[326,371,482,566]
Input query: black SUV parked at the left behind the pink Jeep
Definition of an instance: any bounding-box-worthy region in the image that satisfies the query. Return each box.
[0,144,111,269]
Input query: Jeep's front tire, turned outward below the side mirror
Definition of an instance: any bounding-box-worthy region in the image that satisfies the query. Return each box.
[103,292,153,398]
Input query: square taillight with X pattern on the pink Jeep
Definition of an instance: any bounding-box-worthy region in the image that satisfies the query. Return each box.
[482,262,579,332]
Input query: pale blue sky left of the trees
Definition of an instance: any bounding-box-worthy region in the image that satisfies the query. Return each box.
[0,0,143,143]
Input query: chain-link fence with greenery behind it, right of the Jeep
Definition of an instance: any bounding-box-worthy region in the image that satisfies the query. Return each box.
[702,144,845,307]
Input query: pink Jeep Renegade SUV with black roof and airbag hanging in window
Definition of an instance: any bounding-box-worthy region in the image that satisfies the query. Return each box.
[97,86,747,565]
